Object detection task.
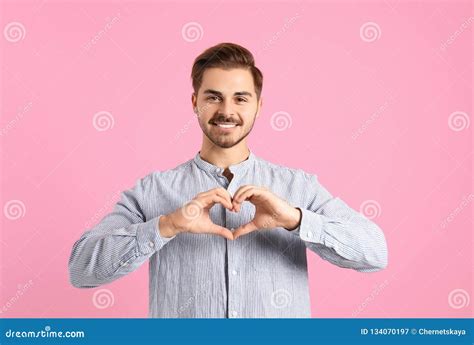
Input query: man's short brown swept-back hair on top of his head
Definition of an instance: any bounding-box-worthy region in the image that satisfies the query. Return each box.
[191,43,263,100]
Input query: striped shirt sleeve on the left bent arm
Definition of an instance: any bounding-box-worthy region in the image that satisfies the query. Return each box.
[69,176,174,288]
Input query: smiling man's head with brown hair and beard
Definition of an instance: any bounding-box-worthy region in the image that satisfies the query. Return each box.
[191,43,263,148]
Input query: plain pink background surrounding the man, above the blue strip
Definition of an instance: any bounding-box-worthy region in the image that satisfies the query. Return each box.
[0,0,474,318]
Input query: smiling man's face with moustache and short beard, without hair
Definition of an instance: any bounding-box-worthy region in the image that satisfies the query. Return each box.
[192,68,261,148]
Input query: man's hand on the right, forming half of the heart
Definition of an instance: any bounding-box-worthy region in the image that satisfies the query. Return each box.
[232,185,301,240]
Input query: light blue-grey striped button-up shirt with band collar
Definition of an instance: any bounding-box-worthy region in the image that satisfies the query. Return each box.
[69,152,387,318]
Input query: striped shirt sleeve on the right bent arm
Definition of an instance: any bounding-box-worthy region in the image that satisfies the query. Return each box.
[291,175,388,272]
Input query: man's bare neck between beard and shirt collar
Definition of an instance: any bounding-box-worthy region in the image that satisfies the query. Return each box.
[199,144,250,169]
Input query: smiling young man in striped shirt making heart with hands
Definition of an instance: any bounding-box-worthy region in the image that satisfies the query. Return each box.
[69,43,387,318]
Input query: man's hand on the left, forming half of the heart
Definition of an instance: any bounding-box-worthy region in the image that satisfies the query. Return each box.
[159,188,234,240]
